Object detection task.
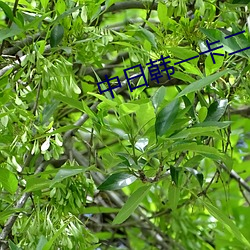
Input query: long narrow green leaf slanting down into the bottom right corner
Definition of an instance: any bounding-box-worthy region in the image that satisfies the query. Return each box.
[203,199,250,248]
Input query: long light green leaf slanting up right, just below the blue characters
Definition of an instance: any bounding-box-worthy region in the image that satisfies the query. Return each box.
[177,70,230,98]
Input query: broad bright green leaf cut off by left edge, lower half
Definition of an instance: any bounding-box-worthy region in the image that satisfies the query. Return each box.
[0,168,18,194]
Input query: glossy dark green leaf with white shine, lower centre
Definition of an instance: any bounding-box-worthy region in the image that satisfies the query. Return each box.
[98,172,136,190]
